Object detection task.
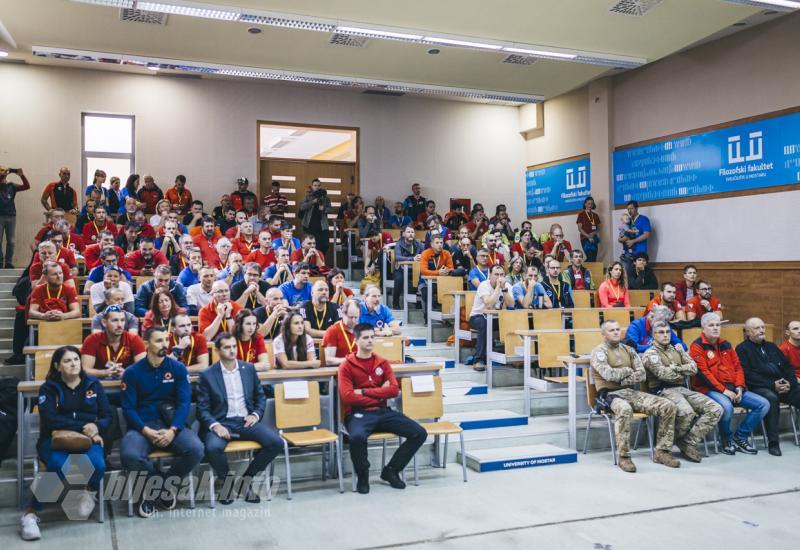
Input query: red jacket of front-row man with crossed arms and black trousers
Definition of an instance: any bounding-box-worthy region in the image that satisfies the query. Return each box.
[339,352,400,416]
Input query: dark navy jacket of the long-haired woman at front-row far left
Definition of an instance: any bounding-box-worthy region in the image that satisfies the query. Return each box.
[39,375,111,439]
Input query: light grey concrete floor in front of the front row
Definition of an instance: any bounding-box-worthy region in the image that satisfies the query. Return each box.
[0,446,800,550]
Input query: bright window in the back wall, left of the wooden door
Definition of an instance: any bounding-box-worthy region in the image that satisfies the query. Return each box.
[81,113,135,195]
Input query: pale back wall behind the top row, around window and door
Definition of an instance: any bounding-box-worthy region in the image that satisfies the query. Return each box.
[0,64,525,263]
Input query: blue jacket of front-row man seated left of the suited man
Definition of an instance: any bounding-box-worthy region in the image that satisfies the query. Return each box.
[120,357,192,431]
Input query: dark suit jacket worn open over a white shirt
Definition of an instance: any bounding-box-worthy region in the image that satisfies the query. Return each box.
[197,361,267,436]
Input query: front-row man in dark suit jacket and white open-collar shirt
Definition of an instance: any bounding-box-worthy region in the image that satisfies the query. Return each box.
[197,332,283,504]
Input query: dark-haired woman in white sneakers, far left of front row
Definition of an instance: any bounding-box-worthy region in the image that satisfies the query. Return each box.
[19,346,111,540]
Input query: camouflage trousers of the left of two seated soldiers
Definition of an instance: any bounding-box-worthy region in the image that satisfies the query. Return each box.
[608,388,676,456]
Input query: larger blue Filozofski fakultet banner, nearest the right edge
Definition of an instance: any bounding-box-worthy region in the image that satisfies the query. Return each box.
[613,113,800,206]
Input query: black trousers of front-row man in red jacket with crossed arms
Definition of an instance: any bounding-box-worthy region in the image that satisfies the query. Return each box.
[344,408,428,474]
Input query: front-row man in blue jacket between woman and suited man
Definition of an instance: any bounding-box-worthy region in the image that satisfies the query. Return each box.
[120,330,203,518]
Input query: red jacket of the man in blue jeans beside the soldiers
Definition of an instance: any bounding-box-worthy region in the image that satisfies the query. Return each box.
[689,334,745,393]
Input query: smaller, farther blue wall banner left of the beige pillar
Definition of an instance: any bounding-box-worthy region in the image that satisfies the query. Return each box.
[525,155,592,216]
